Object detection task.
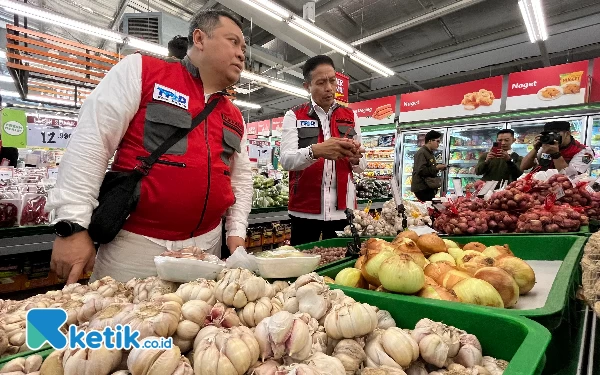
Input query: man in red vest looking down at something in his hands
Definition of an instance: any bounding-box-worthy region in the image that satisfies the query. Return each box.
[281,55,366,245]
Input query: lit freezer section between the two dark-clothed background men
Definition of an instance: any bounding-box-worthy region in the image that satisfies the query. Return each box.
[446,123,506,193]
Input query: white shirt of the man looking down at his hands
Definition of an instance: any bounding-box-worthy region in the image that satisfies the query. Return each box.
[280,98,367,221]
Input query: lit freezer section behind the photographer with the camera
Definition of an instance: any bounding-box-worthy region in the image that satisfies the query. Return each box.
[509,116,586,162]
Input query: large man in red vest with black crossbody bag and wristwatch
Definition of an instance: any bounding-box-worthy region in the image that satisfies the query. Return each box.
[47,10,252,283]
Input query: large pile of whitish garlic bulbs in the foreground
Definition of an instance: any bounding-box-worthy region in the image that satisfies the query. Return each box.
[0,269,507,375]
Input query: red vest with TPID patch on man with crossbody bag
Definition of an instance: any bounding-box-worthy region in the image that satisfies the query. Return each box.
[112,56,244,241]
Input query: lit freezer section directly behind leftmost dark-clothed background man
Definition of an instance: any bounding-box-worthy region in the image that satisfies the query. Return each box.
[396,129,446,200]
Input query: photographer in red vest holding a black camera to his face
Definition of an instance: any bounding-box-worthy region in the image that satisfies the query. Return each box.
[521,121,594,177]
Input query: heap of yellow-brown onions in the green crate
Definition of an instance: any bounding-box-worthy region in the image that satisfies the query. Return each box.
[335,230,535,308]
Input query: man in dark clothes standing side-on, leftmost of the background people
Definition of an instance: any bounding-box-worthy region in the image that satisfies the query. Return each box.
[410,130,447,202]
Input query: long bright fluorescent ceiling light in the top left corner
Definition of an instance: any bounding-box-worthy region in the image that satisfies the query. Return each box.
[0,0,123,43]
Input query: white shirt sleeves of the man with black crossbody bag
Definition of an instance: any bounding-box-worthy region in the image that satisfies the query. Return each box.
[46,54,252,243]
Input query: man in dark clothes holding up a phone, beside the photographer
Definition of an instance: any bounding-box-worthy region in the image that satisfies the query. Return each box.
[475,129,523,187]
